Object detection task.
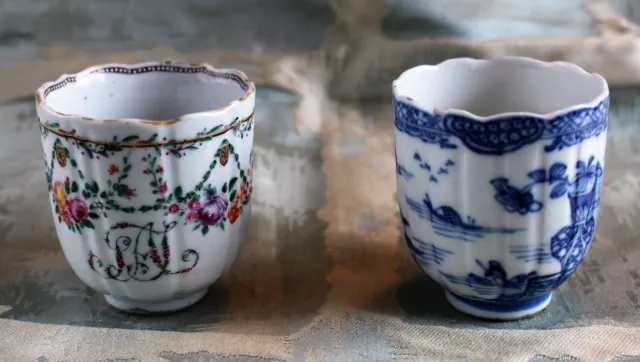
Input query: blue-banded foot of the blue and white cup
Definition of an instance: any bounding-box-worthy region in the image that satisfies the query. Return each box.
[445,291,551,321]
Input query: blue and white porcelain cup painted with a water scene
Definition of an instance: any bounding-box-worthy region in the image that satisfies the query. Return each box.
[393,57,609,320]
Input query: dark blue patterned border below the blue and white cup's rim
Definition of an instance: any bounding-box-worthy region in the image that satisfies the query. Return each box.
[393,96,609,155]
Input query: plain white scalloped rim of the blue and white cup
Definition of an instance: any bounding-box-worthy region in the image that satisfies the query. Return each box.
[392,56,609,121]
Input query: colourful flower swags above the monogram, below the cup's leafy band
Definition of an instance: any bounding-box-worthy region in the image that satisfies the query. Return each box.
[47,139,252,235]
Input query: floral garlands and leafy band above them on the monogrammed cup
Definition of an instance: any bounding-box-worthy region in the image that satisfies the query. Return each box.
[42,117,253,235]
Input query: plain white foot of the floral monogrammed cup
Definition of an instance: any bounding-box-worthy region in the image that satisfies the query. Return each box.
[104,289,208,314]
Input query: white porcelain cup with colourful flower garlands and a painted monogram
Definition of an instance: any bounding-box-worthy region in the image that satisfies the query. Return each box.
[36,62,255,313]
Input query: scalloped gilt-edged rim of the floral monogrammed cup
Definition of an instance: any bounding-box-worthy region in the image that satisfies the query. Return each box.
[36,60,256,125]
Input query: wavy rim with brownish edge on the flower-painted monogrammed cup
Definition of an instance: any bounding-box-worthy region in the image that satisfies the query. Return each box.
[35,61,256,125]
